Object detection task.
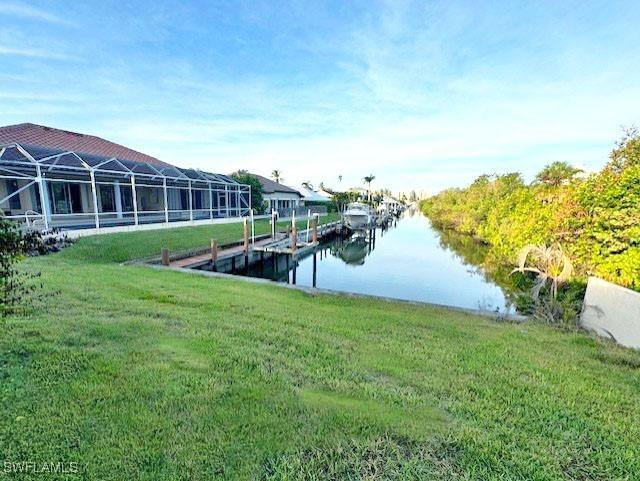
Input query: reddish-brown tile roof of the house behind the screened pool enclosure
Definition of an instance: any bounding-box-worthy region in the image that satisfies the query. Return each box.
[0,123,171,167]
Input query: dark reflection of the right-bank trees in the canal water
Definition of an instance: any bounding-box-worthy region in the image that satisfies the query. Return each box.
[432,225,525,304]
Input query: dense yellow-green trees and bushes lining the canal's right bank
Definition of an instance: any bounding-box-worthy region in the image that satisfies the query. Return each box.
[421,129,640,291]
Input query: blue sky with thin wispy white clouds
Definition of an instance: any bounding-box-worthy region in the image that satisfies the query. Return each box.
[0,0,640,193]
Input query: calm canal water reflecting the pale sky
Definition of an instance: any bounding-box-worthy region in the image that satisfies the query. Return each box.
[234,210,515,313]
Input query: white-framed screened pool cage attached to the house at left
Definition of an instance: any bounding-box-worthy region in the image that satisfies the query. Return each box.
[0,143,251,230]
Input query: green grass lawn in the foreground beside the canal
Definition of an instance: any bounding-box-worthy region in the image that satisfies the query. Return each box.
[0,218,640,481]
